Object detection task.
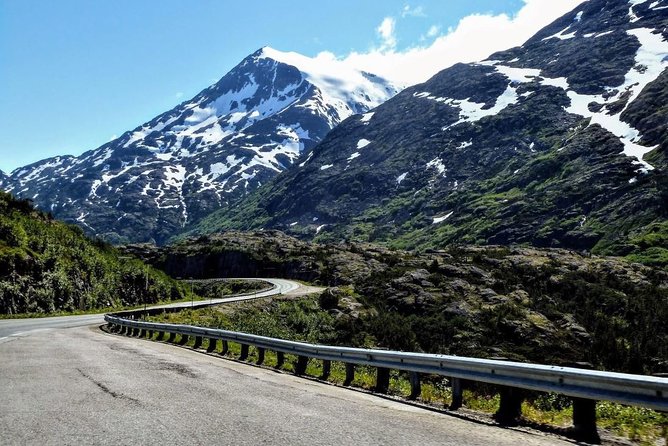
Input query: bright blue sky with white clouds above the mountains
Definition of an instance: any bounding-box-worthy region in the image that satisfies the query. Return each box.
[0,0,579,172]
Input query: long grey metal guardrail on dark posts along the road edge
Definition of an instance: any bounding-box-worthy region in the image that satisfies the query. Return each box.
[105,313,668,442]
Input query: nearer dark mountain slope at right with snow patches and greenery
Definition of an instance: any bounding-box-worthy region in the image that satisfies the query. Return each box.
[188,0,668,262]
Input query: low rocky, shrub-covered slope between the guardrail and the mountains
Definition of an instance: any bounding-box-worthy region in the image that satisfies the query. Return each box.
[126,231,668,373]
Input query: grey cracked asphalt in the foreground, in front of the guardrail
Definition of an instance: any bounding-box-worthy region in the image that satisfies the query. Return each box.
[0,326,571,446]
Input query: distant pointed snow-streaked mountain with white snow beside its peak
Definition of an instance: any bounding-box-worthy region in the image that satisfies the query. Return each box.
[2,47,397,243]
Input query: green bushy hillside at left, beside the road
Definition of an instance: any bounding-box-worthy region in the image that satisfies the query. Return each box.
[0,192,184,316]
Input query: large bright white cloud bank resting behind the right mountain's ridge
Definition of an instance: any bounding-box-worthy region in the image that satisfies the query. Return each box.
[334,0,583,85]
